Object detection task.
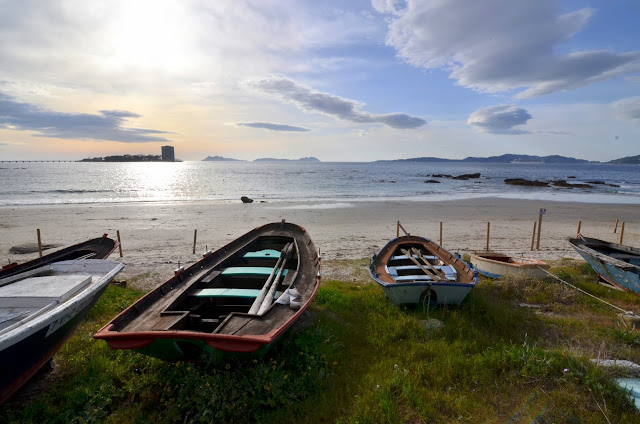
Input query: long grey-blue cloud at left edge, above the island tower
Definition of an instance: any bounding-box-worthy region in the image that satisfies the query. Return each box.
[0,93,168,143]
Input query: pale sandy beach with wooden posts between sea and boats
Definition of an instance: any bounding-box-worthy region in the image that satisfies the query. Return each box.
[0,198,640,289]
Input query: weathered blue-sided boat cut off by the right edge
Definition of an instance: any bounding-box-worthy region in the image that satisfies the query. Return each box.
[569,234,640,294]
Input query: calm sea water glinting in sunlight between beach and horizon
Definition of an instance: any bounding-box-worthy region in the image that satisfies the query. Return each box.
[0,162,640,206]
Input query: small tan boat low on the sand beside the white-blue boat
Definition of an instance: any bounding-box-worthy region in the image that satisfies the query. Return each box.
[470,252,549,279]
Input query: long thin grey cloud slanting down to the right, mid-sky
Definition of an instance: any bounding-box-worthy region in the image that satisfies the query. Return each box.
[247,77,427,129]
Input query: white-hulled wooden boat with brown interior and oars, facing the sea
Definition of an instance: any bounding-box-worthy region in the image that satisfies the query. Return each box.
[369,235,478,305]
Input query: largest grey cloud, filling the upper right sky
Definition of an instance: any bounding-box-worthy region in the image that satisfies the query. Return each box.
[373,0,640,97]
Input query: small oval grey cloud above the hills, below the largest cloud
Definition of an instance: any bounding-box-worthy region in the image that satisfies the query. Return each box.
[467,105,531,134]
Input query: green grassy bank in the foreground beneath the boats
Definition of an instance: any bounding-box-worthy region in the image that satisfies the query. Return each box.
[0,260,640,423]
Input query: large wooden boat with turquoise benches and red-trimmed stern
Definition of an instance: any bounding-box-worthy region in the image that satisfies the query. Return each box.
[94,221,320,361]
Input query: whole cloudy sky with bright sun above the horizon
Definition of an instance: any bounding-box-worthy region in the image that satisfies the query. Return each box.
[0,0,640,162]
